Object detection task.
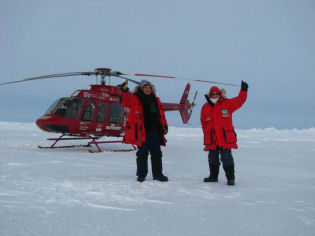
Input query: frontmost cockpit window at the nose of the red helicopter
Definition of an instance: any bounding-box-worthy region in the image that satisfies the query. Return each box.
[53,98,82,118]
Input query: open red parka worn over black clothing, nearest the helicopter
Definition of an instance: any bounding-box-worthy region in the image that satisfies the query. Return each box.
[121,88,167,146]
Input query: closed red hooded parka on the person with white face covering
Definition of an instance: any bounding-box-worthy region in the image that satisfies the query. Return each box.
[200,86,247,151]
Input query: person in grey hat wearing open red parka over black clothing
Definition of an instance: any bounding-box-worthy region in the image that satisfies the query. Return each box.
[121,80,168,182]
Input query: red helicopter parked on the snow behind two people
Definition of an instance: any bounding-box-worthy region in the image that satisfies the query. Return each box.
[0,68,237,153]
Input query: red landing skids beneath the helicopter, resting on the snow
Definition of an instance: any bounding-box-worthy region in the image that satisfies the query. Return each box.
[38,134,137,153]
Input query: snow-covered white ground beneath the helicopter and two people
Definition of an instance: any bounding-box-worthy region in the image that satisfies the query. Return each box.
[0,122,315,236]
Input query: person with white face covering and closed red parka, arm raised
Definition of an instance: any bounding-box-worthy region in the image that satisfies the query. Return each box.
[200,81,248,185]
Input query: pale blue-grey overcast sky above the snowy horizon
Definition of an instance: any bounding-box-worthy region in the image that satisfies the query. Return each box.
[0,0,315,129]
